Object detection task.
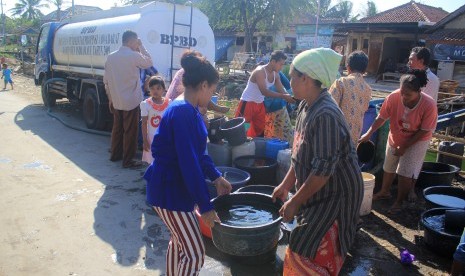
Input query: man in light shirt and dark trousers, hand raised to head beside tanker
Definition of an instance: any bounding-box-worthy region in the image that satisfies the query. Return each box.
[103,31,153,168]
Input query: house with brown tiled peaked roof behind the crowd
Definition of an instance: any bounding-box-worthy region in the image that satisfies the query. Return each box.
[335,1,448,74]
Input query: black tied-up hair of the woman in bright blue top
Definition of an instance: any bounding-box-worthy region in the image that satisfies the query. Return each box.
[181,50,220,87]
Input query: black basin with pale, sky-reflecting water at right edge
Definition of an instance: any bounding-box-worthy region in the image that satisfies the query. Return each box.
[423,186,465,209]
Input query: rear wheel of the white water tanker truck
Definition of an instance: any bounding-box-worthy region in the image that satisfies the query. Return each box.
[82,88,106,129]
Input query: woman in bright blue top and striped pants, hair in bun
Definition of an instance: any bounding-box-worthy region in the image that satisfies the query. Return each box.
[144,51,231,275]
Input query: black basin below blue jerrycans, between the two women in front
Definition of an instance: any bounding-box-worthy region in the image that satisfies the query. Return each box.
[234,155,278,186]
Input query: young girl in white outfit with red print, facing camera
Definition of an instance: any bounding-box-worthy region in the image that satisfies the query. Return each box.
[140,76,170,164]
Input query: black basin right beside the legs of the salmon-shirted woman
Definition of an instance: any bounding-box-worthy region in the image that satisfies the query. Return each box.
[417,162,460,188]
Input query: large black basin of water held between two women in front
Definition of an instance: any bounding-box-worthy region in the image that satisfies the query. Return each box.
[212,193,282,257]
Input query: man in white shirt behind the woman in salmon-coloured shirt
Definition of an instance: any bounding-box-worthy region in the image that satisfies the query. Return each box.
[408,47,439,101]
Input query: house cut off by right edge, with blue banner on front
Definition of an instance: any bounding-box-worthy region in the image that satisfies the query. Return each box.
[426,5,465,88]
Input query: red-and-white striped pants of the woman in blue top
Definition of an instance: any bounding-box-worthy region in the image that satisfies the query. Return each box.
[153,206,205,276]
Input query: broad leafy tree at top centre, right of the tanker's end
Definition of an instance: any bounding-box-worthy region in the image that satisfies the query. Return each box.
[199,0,315,51]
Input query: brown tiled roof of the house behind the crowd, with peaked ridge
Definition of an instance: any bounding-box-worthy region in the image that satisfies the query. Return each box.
[359,0,451,23]
